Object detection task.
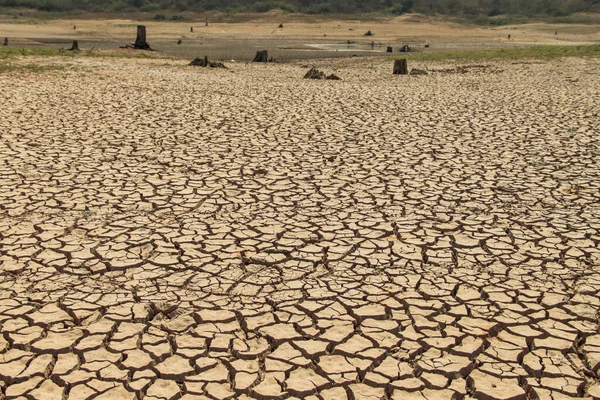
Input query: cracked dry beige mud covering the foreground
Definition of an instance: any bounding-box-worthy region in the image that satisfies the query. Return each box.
[0,58,600,400]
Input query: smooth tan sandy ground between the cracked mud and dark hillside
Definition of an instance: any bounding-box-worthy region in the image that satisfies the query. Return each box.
[0,15,600,60]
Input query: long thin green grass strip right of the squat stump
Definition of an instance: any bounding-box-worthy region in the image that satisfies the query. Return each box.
[394,45,600,60]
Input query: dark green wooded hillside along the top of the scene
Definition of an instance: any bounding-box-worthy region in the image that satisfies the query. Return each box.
[0,0,600,17]
